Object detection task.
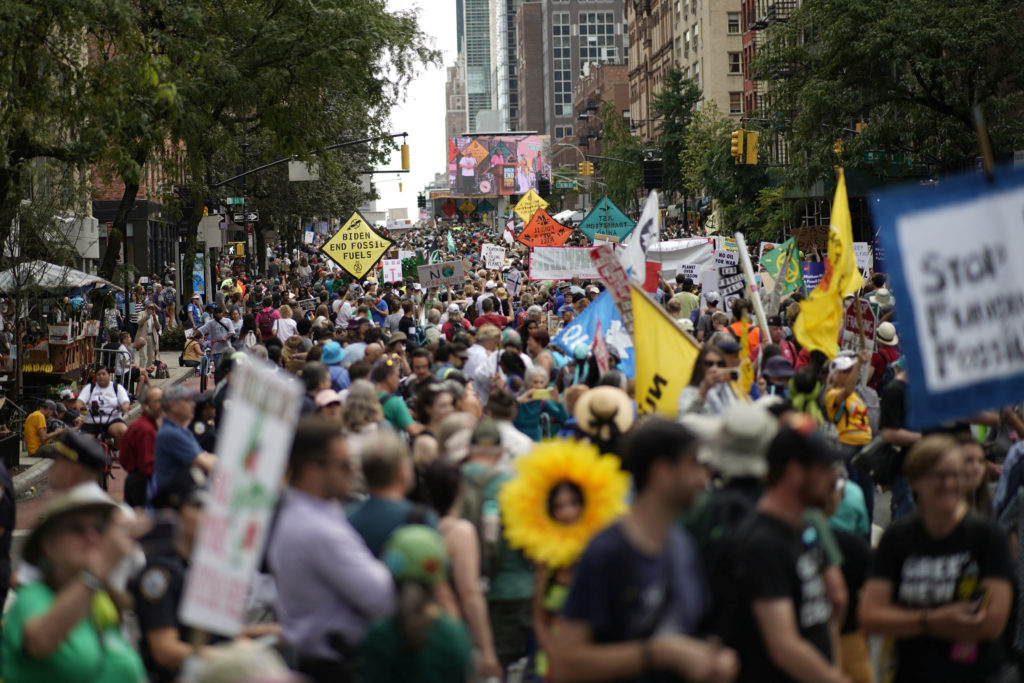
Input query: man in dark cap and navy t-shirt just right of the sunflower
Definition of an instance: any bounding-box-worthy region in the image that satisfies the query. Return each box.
[547,417,738,681]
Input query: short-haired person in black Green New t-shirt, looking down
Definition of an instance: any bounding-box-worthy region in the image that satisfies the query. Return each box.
[860,434,1020,683]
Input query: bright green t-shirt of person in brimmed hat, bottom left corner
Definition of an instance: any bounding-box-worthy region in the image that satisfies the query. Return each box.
[3,582,145,683]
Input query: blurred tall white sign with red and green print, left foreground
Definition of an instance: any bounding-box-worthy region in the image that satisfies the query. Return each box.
[178,364,302,637]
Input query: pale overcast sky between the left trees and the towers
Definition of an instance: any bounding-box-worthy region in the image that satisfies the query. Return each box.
[374,0,457,219]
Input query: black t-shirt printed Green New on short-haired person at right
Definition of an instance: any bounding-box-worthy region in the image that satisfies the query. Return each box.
[871,514,1013,683]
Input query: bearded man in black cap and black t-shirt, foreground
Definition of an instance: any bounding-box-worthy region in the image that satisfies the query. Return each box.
[724,414,848,683]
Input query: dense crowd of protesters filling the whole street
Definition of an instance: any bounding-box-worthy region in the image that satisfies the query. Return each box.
[8,227,1024,683]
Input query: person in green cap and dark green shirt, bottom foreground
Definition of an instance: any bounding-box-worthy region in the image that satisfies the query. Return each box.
[362,524,474,683]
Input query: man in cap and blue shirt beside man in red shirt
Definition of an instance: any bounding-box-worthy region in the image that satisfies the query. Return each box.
[150,386,217,494]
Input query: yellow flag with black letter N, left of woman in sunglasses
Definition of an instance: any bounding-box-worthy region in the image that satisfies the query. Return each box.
[631,285,698,418]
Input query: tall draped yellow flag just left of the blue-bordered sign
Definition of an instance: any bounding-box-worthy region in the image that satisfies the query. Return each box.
[793,170,864,358]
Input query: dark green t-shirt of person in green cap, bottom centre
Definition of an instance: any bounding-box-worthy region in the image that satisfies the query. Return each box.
[362,614,472,683]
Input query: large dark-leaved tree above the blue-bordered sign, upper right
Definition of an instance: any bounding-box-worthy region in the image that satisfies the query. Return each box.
[754,0,1024,187]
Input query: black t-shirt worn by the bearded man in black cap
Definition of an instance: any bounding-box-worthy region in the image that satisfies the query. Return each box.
[729,512,831,683]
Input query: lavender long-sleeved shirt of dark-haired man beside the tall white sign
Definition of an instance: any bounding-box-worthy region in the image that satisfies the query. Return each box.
[267,488,395,659]
